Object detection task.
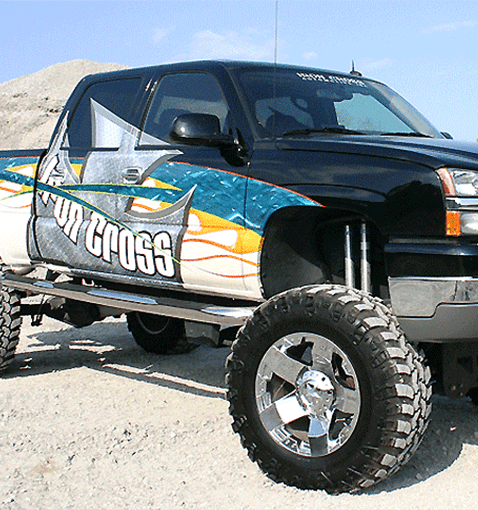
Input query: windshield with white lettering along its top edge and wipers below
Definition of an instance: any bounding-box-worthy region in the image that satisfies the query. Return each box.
[233,67,442,138]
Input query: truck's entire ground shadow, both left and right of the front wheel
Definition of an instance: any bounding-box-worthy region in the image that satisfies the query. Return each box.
[2,320,478,494]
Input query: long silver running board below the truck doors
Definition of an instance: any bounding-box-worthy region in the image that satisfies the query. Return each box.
[0,272,255,326]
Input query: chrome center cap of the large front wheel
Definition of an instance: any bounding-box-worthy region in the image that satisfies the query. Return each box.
[296,370,335,417]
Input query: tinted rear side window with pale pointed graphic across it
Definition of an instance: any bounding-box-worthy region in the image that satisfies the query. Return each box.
[66,78,141,148]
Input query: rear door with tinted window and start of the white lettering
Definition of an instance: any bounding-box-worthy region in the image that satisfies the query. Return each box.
[31,77,148,272]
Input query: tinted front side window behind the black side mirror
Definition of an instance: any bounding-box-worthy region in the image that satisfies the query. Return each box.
[141,73,228,144]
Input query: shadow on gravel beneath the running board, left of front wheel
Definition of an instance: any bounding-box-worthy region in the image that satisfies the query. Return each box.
[7,320,229,399]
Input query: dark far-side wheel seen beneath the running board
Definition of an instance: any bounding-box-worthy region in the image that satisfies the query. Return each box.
[126,312,185,354]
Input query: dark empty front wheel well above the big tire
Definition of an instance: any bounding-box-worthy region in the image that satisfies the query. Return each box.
[261,207,388,298]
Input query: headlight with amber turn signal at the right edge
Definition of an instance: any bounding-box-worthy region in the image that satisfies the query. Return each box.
[437,168,478,237]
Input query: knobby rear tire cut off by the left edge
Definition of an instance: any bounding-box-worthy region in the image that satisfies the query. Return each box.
[0,287,22,372]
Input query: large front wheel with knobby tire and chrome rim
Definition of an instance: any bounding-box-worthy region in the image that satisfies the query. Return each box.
[227,286,431,493]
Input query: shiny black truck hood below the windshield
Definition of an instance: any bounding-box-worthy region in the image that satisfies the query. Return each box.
[278,135,478,170]
